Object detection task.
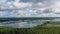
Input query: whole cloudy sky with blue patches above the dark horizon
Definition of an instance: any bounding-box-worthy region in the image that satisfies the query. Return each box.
[0,0,60,17]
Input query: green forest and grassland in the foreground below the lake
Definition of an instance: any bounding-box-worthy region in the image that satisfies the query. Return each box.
[0,22,60,34]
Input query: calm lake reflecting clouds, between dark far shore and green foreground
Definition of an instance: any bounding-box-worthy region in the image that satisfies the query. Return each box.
[1,20,48,28]
